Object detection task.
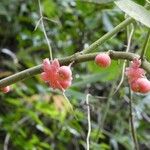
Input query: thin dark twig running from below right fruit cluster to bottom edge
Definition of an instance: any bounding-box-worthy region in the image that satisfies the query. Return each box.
[129,88,139,150]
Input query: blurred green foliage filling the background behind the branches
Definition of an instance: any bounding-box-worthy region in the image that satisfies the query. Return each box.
[0,0,150,150]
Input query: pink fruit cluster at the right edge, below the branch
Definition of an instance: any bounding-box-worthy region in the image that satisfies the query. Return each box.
[125,58,150,93]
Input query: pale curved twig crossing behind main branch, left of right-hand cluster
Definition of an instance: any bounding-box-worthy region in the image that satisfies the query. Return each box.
[113,24,135,95]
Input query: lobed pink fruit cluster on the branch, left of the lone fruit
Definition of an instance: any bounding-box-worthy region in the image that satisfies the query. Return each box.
[41,58,72,91]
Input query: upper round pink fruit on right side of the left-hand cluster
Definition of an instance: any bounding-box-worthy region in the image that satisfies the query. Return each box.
[58,66,72,80]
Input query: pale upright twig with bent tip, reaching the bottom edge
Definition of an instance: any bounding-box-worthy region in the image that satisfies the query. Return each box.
[86,94,91,150]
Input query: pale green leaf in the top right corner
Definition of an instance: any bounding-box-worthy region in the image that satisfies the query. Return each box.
[115,0,150,28]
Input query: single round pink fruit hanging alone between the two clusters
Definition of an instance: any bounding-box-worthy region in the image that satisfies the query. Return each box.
[95,53,111,68]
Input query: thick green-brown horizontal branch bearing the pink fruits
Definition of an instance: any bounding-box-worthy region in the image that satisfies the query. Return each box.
[0,50,150,88]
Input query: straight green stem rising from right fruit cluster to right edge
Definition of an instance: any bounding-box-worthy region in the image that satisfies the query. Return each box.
[140,29,150,60]
